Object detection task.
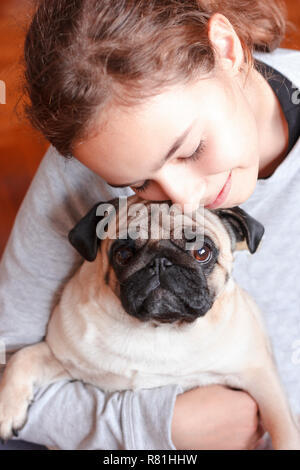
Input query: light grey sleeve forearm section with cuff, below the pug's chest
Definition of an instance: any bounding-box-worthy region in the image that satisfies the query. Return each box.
[0,362,182,450]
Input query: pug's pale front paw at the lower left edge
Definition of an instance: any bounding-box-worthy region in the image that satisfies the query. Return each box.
[0,385,33,442]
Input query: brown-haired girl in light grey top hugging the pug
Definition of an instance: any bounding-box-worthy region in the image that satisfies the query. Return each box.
[0,0,300,449]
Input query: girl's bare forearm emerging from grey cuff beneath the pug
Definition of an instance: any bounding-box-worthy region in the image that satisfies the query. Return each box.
[172,385,265,450]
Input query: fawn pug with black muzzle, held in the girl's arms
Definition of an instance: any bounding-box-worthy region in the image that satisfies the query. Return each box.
[0,195,300,450]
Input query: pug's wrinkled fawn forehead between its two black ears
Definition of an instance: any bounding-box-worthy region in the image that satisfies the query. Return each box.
[98,195,230,251]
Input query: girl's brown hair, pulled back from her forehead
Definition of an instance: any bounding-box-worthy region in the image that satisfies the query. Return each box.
[24,0,286,158]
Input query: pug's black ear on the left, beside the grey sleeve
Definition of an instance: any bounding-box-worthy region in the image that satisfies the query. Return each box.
[68,198,118,261]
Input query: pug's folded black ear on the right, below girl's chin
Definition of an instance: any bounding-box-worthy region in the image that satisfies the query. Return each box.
[216,206,265,254]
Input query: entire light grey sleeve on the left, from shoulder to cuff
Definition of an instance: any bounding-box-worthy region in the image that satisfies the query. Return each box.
[0,147,182,450]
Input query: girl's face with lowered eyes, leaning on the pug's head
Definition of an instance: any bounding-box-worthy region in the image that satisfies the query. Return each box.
[73,69,259,208]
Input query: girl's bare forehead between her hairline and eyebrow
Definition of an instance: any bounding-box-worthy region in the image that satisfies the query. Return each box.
[73,78,232,184]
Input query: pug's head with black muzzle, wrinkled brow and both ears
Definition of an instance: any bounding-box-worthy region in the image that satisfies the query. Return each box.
[69,195,264,324]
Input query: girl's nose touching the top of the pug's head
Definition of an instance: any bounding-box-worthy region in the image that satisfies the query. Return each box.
[156,167,206,210]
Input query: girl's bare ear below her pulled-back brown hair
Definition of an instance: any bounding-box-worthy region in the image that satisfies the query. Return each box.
[208,13,244,75]
